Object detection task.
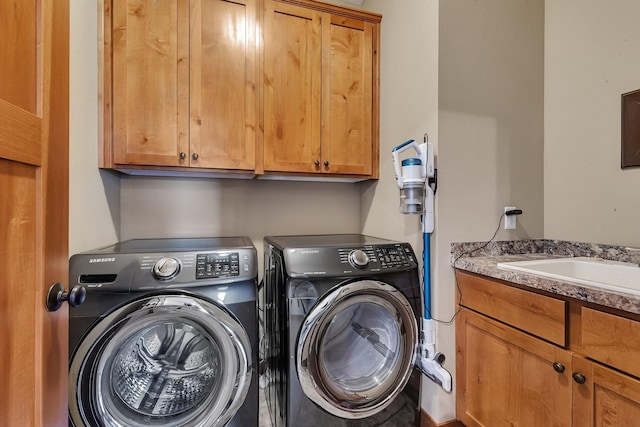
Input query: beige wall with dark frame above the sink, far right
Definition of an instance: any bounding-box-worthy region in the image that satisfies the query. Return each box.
[544,0,640,247]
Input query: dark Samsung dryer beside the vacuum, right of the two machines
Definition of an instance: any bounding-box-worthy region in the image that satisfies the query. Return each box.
[264,234,422,427]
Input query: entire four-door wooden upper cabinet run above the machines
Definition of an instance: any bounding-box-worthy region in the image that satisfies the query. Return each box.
[100,0,381,179]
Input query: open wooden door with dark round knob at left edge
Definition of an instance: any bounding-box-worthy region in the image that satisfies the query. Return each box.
[0,0,69,426]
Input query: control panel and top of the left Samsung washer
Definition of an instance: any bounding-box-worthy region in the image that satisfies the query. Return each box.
[69,237,258,292]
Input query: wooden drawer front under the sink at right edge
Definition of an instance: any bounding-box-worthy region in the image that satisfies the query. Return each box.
[580,307,640,377]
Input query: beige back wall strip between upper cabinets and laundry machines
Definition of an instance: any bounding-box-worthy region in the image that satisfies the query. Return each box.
[121,176,360,271]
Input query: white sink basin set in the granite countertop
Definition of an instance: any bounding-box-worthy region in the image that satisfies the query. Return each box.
[498,257,640,295]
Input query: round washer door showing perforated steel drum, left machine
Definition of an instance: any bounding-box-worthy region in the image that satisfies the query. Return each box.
[69,294,252,427]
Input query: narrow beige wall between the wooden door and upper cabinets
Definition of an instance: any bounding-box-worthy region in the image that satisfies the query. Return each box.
[69,0,120,255]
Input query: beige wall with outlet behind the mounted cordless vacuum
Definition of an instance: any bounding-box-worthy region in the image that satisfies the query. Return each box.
[362,0,544,422]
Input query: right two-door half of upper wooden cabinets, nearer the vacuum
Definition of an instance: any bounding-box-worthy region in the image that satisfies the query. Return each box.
[264,0,381,178]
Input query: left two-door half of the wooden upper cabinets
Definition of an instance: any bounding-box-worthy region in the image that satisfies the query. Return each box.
[101,0,257,171]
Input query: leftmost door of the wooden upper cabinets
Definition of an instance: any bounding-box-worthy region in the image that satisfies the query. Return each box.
[111,0,189,166]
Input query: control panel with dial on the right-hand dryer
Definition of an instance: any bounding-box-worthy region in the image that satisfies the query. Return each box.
[284,243,418,277]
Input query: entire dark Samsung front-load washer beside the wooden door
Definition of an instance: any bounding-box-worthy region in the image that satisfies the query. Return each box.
[69,237,258,427]
